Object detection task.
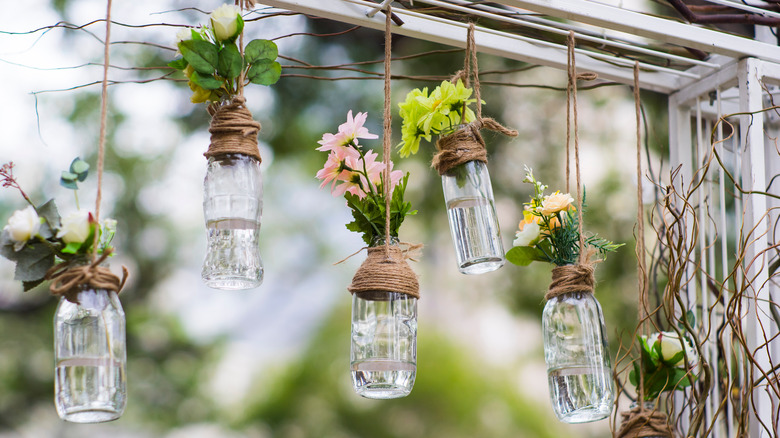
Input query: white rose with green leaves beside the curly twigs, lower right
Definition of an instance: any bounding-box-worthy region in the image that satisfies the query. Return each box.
[628,332,699,401]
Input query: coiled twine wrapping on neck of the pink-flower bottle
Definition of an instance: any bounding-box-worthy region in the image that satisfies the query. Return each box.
[347,246,420,301]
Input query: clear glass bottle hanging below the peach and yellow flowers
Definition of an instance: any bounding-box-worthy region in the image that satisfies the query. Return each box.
[542,293,615,423]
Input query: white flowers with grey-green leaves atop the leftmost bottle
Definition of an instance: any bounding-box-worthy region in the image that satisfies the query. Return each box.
[0,158,116,291]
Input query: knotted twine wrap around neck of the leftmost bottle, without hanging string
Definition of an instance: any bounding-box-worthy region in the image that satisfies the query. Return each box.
[44,251,128,304]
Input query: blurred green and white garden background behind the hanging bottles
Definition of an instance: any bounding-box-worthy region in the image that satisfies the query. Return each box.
[0,0,666,438]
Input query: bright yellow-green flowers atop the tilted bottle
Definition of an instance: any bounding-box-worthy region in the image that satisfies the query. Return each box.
[398,79,476,157]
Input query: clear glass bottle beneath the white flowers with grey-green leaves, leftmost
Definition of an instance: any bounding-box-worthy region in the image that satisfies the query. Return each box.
[54,288,127,423]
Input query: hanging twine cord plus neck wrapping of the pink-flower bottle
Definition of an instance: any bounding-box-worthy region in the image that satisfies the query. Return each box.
[347,4,422,301]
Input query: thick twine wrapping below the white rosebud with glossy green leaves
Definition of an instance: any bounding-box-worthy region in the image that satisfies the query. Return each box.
[203,96,262,161]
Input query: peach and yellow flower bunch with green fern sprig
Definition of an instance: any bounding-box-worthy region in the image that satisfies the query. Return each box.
[506,167,623,266]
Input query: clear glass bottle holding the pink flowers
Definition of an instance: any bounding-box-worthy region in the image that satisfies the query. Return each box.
[350,238,417,399]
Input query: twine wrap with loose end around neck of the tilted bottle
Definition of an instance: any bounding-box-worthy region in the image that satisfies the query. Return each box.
[431,118,517,175]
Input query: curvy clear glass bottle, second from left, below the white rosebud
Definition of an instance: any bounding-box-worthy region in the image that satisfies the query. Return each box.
[201,154,263,290]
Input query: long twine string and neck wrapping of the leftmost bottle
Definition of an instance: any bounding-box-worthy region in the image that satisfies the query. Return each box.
[44,0,128,304]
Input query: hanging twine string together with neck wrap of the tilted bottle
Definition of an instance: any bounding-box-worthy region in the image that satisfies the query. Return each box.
[431,23,517,175]
